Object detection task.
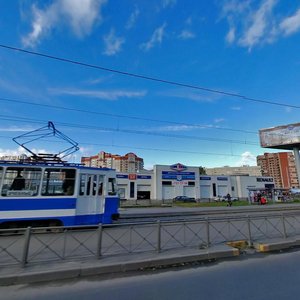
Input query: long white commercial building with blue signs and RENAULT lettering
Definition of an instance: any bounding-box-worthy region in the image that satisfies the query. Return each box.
[117,163,275,201]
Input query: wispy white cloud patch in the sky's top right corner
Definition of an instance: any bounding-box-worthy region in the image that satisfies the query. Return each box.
[221,0,300,50]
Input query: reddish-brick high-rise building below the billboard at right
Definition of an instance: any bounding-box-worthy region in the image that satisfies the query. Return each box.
[257,152,299,188]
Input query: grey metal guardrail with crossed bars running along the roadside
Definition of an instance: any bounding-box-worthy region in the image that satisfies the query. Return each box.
[0,213,300,267]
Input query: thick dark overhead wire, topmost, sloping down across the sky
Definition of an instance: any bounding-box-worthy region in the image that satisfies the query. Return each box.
[0,44,300,109]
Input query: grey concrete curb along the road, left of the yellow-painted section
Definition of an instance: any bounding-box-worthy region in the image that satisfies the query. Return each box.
[0,245,240,286]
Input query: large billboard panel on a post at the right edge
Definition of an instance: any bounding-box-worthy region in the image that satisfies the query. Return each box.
[259,123,300,150]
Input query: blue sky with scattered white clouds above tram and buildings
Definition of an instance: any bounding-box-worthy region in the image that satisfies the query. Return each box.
[0,0,300,169]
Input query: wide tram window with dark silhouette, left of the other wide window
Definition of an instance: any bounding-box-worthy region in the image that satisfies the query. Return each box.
[1,167,42,197]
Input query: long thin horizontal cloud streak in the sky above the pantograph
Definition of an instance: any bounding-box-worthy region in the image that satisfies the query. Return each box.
[49,88,147,101]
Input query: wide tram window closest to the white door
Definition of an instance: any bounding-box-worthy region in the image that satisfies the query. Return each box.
[42,168,76,196]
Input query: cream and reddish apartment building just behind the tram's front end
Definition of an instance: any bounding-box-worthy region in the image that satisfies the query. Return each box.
[81,151,144,173]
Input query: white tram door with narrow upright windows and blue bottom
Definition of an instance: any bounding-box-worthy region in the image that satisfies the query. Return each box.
[76,174,104,224]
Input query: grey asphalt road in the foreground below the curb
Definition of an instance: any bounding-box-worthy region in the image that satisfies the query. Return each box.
[0,251,300,300]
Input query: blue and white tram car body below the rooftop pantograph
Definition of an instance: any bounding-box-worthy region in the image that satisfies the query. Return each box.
[0,162,119,228]
